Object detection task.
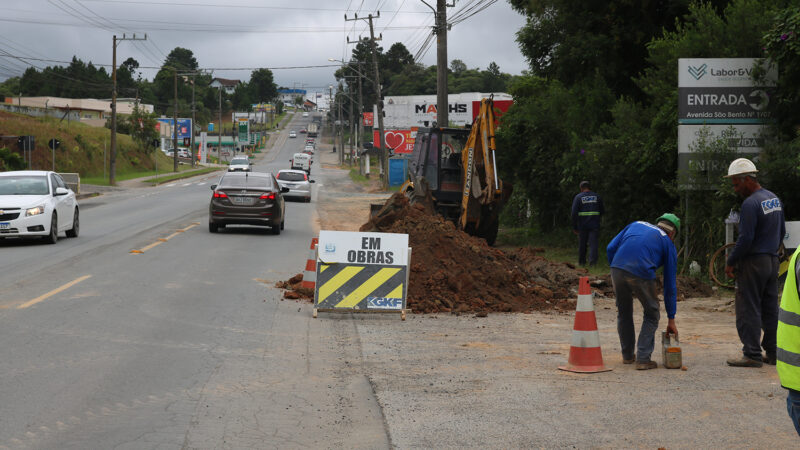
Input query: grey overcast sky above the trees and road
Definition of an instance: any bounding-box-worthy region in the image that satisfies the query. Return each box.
[0,0,527,98]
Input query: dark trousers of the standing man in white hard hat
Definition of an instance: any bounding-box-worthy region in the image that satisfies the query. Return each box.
[736,255,778,361]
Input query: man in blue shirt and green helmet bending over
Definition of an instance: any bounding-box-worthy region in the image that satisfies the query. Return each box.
[606,213,681,370]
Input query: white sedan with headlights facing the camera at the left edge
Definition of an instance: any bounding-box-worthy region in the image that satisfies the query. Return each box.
[0,170,80,244]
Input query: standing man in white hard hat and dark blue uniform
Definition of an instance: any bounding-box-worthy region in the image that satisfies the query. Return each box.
[725,158,786,367]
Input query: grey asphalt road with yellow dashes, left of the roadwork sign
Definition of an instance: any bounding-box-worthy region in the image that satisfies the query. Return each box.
[0,115,389,449]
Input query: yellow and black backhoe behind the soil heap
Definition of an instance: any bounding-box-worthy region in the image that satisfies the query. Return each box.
[400,98,512,245]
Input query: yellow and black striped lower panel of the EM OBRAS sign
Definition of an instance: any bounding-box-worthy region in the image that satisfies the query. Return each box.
[314,261,408,311]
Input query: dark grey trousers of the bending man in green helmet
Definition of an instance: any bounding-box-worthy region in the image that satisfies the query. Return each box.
[611,267,661,361]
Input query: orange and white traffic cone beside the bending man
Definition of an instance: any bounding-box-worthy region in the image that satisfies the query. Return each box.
[558,277,611,373]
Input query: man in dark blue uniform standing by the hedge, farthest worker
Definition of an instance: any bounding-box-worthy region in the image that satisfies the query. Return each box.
[572,181,605,266]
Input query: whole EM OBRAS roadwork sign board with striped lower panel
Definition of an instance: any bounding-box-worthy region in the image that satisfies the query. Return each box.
[314,230,411,320]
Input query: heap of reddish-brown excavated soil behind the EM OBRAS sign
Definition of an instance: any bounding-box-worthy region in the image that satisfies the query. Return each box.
[277,194,711,316]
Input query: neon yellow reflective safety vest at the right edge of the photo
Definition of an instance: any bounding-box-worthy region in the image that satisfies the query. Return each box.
[777,248,800,391]
